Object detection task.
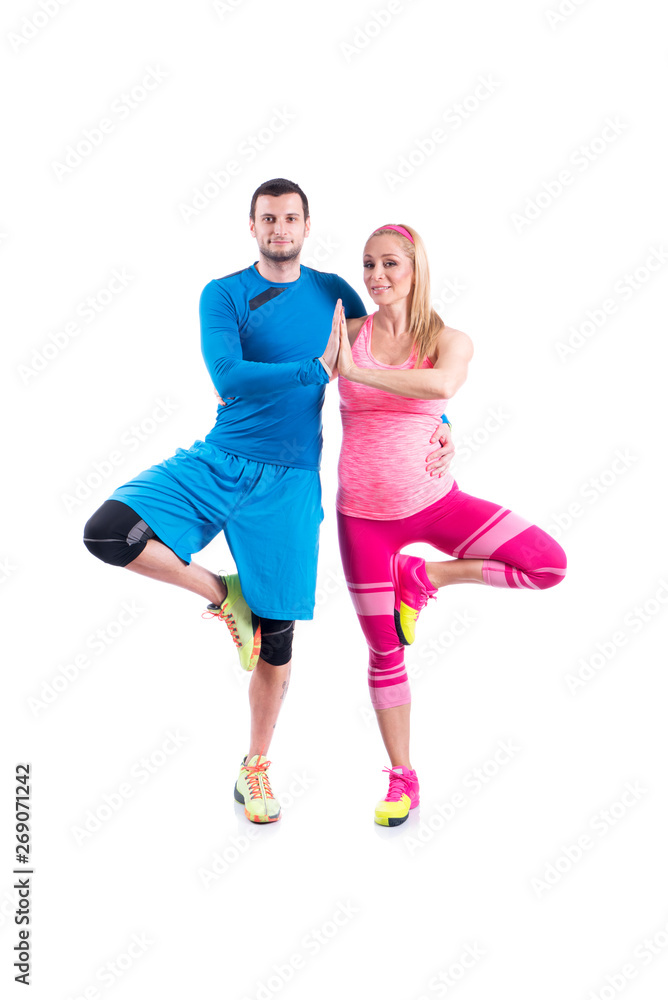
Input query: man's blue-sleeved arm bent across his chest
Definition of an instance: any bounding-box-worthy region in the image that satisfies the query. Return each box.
[199,281,336,399]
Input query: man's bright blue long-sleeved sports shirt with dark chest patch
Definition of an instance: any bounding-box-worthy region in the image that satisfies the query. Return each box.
[200,265,365,470]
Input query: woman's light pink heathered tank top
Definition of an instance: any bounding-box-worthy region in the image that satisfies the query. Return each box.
[336,316,453,521]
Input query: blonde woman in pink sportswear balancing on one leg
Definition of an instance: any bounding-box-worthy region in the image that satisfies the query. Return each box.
[334,225,566,826]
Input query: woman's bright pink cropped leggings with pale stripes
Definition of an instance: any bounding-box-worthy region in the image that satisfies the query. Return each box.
[338,483,566,708]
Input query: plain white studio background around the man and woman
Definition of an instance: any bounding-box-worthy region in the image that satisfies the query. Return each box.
[0,0,668,1000]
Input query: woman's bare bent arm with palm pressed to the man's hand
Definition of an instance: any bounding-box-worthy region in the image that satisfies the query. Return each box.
[337,306,473,399]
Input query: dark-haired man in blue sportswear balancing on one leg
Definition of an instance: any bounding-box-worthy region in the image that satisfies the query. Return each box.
[84,178,452,823]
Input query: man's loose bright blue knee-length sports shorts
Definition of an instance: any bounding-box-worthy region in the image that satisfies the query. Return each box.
[109,441,323,621]
